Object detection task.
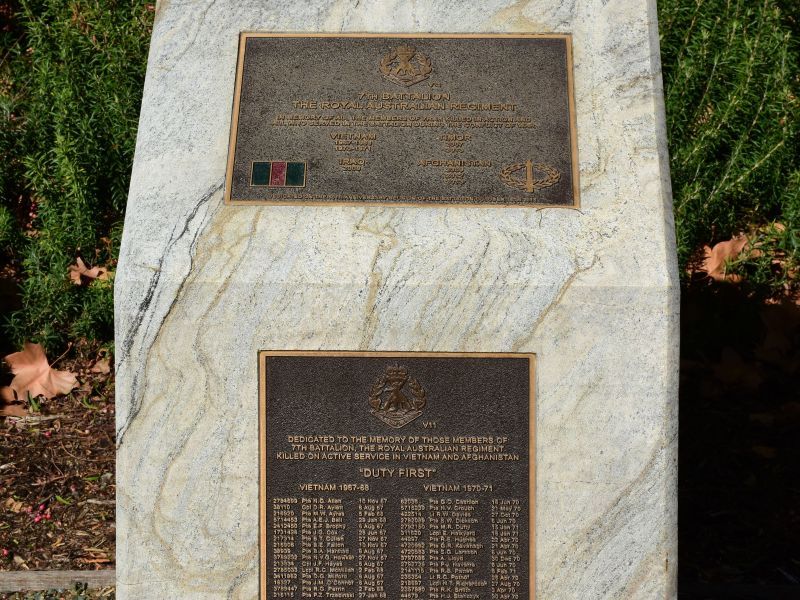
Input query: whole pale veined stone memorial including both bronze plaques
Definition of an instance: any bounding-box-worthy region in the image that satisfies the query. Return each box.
[115,0,678,600]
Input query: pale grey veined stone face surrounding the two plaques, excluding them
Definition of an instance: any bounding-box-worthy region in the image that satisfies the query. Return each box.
[115,0,678,600]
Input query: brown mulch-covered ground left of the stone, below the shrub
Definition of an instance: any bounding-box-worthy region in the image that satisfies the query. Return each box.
[0,352,115,571]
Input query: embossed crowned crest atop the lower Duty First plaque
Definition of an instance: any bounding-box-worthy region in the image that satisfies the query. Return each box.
[369,365,428,429]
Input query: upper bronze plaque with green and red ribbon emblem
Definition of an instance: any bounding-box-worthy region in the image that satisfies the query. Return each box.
[225,33,579,207]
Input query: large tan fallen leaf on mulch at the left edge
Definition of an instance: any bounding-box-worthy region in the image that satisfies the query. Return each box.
[5,342,78,398]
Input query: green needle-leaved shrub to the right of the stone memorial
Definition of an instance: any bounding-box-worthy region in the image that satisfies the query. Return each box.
[659,0,800,293]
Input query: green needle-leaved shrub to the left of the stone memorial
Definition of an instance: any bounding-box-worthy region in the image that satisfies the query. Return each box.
[0,0,152,349]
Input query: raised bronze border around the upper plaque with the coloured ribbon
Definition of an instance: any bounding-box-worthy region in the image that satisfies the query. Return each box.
[224,31,581,210]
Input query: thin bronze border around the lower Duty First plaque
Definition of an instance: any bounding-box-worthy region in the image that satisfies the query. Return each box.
[258,350,536,600]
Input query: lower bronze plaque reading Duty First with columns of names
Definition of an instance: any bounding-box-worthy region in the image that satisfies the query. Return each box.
[259,351,535,600]
